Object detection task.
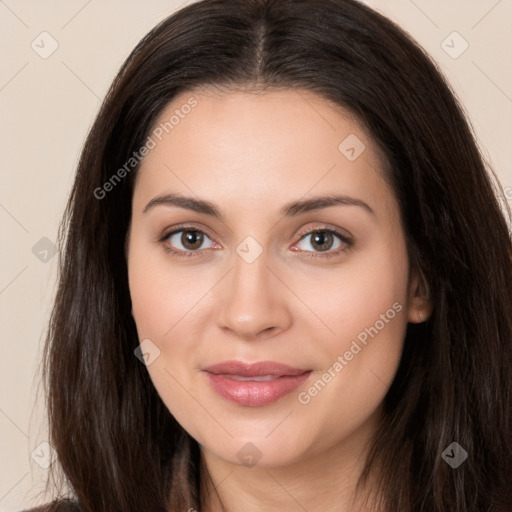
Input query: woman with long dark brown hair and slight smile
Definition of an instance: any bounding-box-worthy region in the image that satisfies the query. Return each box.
[26,0,512,512]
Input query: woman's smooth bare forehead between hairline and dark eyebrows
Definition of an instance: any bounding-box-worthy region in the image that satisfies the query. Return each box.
[136,89,392,220]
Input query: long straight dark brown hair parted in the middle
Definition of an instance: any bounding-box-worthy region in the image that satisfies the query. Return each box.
[30,0,512,512]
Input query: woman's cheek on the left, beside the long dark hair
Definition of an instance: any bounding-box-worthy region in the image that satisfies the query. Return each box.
[128,250,211,430]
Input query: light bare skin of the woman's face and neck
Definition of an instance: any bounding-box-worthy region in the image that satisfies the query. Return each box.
[127,89,430,512]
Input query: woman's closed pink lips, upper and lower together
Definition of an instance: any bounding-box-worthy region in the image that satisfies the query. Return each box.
[203,361,312,407]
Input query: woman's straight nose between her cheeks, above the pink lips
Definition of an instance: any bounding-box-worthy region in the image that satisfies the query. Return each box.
[218,247,292,340]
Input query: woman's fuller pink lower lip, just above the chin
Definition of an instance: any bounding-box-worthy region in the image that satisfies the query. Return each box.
[206,371,311,407]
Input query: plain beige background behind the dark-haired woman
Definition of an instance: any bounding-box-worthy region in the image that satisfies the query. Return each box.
[0,0,512,512]
